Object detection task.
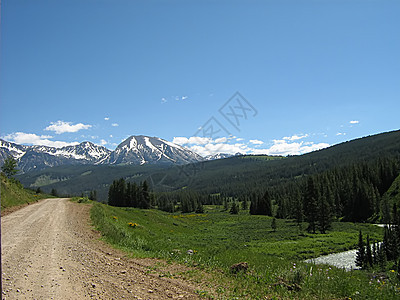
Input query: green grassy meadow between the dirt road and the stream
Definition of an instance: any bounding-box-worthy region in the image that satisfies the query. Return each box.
[91,204,400,299]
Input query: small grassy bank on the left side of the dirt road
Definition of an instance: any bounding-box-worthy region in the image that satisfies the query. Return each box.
[1,175,50,211]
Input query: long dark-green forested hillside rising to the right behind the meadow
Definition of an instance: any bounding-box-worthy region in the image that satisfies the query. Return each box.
[16,131,400,222]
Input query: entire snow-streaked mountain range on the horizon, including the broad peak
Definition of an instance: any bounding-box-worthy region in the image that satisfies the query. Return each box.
[0,135,220,173]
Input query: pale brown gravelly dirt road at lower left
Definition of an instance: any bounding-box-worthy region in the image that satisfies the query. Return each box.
[1,199,197,300]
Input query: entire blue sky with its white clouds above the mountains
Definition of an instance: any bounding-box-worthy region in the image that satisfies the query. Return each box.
[0,0,400,155]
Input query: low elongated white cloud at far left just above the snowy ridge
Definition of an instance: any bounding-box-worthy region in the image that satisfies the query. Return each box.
[3,132,79,148]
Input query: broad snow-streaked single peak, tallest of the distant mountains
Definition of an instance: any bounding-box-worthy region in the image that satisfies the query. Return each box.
[102,135,204,165]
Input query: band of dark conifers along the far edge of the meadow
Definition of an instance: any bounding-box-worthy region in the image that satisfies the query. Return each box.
[108,157,399,233]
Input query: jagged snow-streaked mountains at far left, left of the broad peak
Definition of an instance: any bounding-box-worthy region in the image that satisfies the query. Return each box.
[0,139,111,172]
